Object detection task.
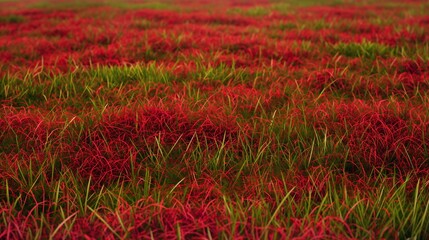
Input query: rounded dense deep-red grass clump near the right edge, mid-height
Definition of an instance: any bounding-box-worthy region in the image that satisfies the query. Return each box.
[347,112,424,173]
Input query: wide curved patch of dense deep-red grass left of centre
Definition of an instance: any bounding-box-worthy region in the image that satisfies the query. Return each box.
[70,104,238,183]
